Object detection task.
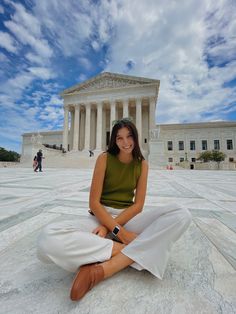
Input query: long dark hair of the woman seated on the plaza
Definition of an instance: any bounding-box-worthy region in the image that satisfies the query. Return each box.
[107,118,145,161]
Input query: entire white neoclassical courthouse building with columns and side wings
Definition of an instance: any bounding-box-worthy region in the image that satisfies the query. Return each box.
[21,72,236,168]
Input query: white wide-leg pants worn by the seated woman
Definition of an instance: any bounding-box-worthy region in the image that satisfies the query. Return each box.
[37,204,191,279]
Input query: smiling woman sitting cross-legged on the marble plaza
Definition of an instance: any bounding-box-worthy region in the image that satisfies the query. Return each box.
[38,118,191,301]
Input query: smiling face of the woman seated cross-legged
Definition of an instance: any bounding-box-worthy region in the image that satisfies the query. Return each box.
[116,127,134,154]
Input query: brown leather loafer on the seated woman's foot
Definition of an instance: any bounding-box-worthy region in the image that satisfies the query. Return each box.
[70,264,104,301]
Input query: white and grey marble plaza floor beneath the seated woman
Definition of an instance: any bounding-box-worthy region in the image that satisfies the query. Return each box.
[0,168,236,314]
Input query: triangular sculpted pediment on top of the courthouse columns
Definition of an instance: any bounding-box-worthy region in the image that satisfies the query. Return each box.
[62,72,159,95]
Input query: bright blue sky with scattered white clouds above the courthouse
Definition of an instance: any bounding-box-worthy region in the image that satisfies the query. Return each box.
[0,0,236,152]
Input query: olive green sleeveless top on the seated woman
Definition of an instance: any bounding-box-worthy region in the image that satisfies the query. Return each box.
[101,153,142,209]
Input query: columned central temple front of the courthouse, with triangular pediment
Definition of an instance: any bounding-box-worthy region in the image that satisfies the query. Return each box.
[61,72,160,153]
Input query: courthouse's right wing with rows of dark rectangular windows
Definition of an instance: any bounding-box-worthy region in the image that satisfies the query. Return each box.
[150,121,236,166]
